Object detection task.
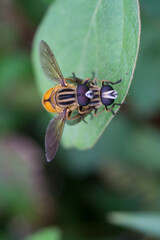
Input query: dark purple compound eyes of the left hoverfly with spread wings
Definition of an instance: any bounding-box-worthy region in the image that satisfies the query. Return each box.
[77,84,90,107]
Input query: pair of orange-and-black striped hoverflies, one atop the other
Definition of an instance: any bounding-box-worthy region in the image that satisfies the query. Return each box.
[39,40,122,162]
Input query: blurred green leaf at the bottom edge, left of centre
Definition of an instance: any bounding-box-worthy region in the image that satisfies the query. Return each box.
[25,227,62,240]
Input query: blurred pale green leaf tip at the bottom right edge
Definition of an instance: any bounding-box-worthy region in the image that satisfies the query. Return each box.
[109,212,160,237]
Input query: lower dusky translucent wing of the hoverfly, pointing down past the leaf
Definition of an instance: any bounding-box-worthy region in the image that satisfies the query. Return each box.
[45,111,66,162]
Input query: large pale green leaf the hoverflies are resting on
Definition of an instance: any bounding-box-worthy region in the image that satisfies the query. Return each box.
[32,0,140,149]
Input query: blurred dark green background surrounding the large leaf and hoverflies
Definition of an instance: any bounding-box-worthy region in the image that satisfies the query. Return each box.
[0,0,160,240]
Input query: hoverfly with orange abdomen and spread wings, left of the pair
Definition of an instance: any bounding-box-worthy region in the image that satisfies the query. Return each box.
[39,41,93,162]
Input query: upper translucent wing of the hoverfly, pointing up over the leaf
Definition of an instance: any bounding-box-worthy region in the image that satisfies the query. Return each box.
[39,40,66,86]
